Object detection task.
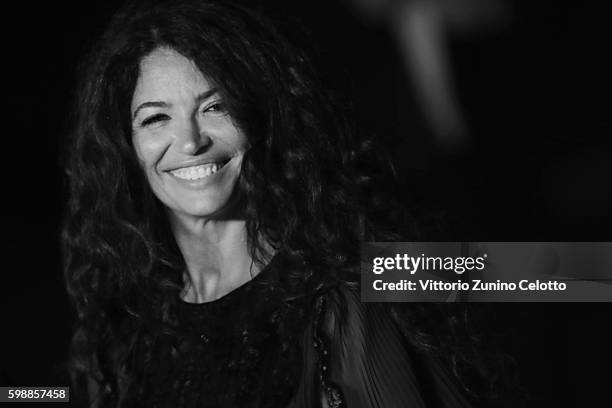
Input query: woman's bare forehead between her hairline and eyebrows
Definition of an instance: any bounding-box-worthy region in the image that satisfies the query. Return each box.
[132,48,212,111]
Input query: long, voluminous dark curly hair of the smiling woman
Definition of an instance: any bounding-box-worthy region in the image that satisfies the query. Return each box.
[62,1,520,406]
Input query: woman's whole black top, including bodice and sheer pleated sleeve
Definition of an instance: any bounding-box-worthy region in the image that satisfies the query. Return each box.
[140,257,468,408]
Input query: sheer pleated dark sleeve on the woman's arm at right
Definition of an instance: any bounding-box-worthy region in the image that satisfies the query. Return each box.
[315,283,470,408]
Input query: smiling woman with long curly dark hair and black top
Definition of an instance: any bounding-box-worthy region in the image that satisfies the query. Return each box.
[63,1,482,407]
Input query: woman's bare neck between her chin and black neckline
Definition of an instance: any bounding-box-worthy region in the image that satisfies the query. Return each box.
[170,214,260,303]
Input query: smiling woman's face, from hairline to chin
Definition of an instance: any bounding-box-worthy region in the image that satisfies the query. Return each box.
[131,48,247,217]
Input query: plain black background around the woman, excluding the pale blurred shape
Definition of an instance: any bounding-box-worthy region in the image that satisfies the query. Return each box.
[0,0,612,407]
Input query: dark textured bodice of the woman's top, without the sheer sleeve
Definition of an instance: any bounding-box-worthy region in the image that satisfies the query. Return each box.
[142,255,309,408]
